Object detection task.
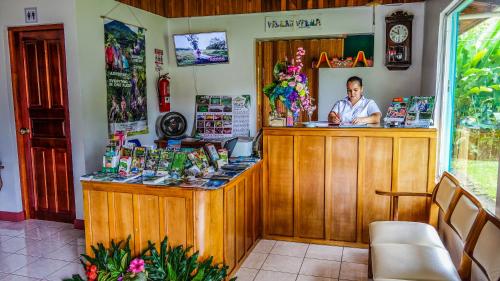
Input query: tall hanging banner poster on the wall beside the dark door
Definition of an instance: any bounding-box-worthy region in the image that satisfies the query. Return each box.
[104,19,148,135]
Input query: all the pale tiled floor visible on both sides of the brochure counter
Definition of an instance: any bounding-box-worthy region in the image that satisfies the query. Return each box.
[0,220,368,281]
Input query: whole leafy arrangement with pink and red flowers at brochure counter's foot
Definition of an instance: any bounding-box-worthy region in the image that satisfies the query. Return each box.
[64,236,236,281]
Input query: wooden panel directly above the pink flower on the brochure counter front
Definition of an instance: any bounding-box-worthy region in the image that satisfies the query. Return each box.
[134,194,159,253]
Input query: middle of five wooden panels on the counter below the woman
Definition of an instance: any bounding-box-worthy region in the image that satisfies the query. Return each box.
[325,137,358,242]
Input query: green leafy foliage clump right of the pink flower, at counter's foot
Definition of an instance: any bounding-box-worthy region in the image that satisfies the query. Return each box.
[142,237,236,281]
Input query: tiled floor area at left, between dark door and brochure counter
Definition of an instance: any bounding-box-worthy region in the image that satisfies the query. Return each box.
[0,220,85,281]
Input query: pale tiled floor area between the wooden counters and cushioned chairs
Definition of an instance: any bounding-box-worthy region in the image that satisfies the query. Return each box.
[232,240,368,281]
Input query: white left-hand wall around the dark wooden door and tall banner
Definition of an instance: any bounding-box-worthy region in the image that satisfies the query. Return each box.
[0,0,166,219]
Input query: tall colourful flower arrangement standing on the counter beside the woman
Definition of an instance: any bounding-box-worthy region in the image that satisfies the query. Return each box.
[263,47,316,116]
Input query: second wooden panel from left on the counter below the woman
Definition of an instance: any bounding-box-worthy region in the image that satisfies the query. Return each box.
[294,136,325,239]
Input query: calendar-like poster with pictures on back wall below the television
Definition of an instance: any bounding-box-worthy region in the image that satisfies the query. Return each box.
[196,95,250,139]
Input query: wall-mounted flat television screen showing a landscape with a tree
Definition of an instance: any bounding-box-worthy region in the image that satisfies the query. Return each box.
[174,32,229,66]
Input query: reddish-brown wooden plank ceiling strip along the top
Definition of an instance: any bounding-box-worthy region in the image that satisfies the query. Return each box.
[118,0,424,18]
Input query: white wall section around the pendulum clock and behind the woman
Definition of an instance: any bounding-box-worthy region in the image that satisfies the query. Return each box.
[318,4,427,120]
